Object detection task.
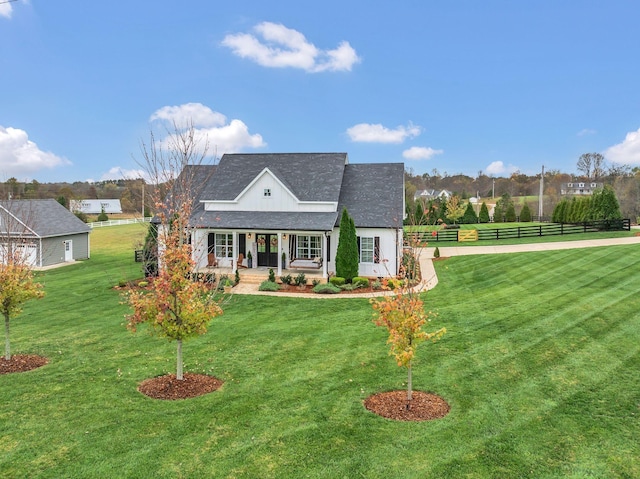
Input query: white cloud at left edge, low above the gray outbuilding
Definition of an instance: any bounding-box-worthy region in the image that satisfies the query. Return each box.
[0,126,71,177]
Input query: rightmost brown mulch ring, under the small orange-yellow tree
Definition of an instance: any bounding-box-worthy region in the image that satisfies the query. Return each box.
[364,390,451,421]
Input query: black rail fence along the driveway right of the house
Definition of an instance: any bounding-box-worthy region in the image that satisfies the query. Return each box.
[407,219,631,243]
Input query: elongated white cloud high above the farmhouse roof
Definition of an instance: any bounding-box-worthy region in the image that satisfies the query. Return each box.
[222,22,360,73]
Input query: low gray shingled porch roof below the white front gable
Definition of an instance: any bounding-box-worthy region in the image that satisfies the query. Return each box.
[190,207,338,231]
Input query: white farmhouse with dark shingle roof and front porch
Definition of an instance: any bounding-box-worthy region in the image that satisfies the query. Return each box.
[180,153,404,277]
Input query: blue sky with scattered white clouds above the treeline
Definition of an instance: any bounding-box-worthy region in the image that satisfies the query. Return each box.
[0,0,640,182]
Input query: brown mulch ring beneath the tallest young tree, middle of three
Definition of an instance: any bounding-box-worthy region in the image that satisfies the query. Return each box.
[138,373,224,400]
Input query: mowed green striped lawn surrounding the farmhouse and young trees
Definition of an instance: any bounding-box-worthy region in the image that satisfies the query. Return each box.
[0,225,640,479]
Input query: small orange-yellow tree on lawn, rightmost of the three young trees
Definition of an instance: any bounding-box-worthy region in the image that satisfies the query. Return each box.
[371,287,446,408]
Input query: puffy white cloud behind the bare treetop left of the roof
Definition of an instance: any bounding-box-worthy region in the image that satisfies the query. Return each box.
[150,103,267,156]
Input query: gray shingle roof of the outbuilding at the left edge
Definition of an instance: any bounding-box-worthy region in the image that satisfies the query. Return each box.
[0,199,91,238]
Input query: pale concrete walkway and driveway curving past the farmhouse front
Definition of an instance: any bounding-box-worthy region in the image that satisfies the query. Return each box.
[233,236,640,299]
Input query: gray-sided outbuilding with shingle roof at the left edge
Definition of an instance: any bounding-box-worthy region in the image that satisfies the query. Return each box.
[0,199,91,268]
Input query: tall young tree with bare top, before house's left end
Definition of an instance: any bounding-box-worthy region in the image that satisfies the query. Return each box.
[127,125,222,380]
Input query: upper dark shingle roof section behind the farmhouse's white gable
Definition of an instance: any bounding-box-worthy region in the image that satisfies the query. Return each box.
[202,153,347,201]
